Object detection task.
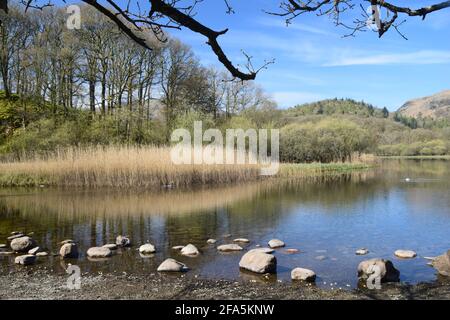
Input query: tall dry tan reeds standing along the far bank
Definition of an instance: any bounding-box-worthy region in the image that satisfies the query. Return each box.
[0,146,370,188]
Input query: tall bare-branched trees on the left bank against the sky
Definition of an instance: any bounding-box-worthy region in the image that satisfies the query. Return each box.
[0,6,275,148]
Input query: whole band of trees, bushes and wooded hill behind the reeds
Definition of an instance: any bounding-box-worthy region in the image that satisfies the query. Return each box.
[0,6,450,162]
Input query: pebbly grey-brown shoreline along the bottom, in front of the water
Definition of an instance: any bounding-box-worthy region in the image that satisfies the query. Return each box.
[0,267,450,300]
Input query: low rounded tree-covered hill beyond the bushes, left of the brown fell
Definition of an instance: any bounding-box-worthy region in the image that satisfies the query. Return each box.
[286,99,389,118]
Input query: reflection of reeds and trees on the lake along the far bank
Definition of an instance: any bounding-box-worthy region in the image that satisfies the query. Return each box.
[0,160,449,250]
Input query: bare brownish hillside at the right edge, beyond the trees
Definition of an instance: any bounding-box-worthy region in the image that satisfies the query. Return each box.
[398,90,450,119]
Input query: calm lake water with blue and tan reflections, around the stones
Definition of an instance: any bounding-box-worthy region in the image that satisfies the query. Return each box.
[0,160,450,288]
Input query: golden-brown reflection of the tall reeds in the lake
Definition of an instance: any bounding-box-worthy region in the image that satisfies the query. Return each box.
[0,182,270,219]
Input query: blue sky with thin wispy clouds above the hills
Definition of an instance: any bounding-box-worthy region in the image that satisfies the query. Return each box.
[163,0,450,110]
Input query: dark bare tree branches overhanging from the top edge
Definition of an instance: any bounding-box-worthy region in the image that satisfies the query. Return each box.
[0,0,450,80]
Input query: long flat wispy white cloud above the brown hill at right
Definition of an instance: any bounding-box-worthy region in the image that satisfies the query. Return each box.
[323,50,450,67]
